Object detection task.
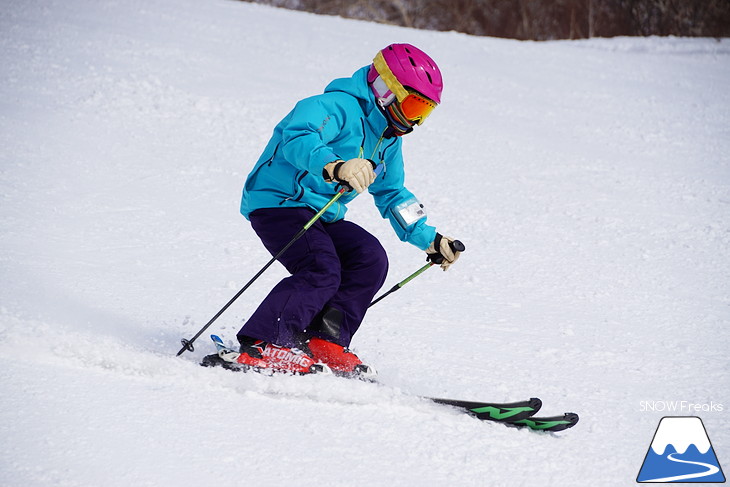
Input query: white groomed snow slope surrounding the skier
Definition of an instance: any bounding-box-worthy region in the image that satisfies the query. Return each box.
[0,0,730,487]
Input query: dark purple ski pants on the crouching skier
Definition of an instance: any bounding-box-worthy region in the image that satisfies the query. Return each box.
[238,208,388,347]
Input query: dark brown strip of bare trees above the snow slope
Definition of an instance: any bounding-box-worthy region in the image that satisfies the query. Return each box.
[239,0,730,40]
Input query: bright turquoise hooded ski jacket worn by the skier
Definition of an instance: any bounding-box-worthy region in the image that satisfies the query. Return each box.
[241,66,436,250]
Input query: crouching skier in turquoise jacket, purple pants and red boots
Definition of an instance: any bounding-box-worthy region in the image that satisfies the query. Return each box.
[237,44,459,375]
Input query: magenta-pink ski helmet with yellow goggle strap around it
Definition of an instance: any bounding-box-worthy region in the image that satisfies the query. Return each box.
[368,44,444,104]
